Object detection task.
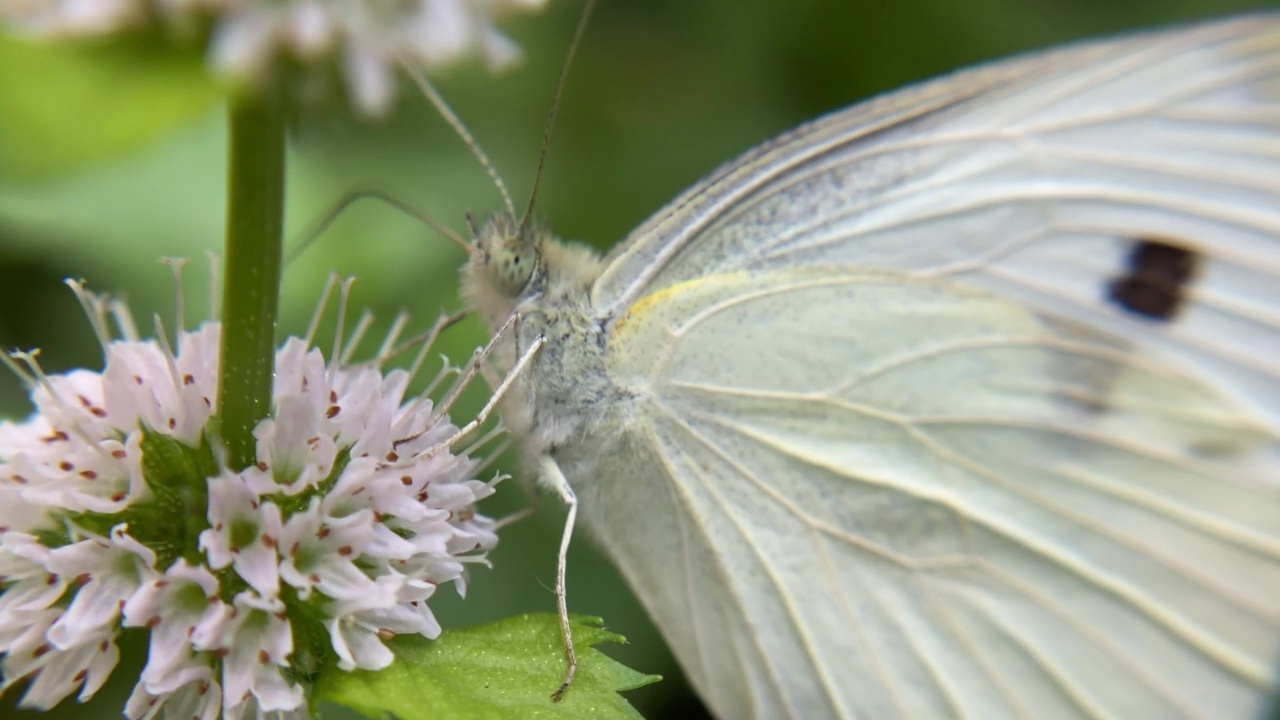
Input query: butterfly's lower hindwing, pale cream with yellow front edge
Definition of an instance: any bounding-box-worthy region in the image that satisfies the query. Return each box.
[582,269,1280,719]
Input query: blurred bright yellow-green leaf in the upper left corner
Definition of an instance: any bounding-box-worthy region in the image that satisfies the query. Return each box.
[0,33,221,178]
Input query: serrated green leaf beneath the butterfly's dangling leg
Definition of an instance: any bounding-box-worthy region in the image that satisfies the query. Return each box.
[316,615,659,720]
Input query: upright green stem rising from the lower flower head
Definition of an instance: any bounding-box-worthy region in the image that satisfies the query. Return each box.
[218,92,284,470]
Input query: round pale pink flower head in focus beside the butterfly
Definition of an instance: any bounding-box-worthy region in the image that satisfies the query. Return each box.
[0,278,497,720]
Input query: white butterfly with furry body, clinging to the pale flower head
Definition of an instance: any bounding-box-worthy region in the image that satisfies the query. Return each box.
[465,14,1280,720]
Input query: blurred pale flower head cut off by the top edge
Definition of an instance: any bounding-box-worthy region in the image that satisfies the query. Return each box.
[0,0,547,115]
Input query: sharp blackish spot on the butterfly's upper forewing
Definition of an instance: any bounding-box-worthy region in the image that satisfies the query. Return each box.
[1107,238,1201,320]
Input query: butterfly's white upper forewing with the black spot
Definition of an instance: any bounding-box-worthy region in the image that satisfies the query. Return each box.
[593,14,1280,425]
